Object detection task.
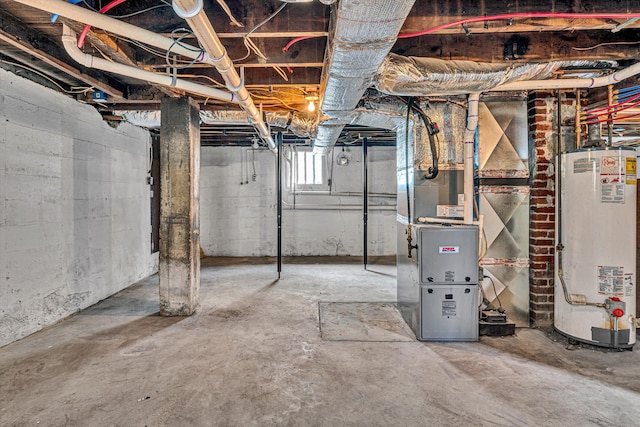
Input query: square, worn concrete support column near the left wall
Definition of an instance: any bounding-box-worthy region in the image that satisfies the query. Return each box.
[160,98,200,316]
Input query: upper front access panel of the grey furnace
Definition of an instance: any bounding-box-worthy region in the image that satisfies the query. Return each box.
[418,225,478,285]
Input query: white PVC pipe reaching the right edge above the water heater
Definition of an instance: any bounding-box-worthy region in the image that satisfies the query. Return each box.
[490,62,640,91]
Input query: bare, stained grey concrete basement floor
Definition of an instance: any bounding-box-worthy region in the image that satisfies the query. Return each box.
[0,258,640,426]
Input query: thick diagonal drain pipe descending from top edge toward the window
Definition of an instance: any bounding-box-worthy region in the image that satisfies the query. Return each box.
[173,0,278,152]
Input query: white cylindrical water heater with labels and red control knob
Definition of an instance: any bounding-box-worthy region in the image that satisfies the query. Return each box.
[554,147,636,348]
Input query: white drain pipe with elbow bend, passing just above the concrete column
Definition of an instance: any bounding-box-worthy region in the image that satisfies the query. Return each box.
[62,24,238,103]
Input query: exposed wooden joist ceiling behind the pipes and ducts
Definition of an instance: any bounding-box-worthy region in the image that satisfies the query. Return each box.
[0,0,640,143]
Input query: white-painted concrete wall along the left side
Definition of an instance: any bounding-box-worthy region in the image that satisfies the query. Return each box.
[0,70,157,346]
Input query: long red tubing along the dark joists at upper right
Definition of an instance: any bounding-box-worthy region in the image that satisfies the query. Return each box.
[398,12,640,39]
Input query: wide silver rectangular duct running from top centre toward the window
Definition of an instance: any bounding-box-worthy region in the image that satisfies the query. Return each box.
[314,0,415,154]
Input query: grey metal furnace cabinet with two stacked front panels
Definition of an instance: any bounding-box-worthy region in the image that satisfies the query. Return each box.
[398,223,479,341]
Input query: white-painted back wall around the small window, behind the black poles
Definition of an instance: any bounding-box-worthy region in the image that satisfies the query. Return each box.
[200,147,396,256]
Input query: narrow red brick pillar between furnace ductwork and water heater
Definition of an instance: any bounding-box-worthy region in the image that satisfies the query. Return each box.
[528,92,556,326]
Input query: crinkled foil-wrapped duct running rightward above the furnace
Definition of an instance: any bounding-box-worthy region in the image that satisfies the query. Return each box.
[374,54,616,96]
